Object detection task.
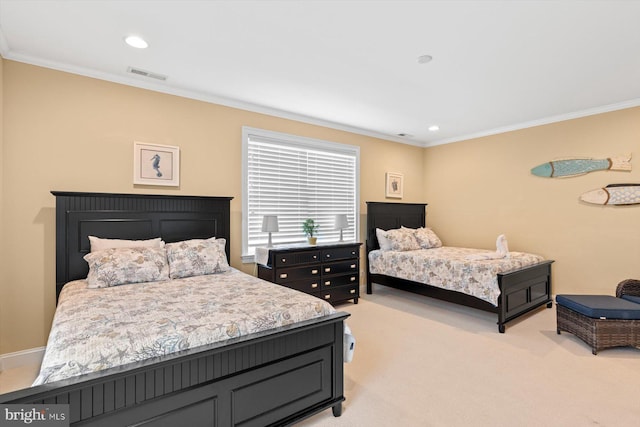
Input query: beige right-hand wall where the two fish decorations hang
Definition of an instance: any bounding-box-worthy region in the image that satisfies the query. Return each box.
[424,108,640,294]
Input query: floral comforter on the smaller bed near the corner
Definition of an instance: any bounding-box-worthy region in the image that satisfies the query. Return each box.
[369,246,543,306]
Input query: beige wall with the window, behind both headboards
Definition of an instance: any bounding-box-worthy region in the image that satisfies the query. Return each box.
[0,60,424,354]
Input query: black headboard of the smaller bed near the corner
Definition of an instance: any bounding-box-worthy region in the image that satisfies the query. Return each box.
[367,202,427,253]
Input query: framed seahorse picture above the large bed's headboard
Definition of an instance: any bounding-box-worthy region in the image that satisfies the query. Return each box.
[133,141,180,187]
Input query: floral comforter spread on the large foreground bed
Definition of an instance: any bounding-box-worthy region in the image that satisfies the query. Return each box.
[34,269,335,385]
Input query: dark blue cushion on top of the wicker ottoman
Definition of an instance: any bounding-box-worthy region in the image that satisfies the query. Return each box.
[556,295,640,320]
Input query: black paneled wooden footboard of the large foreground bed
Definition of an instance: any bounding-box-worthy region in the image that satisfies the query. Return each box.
[0,313,348,427]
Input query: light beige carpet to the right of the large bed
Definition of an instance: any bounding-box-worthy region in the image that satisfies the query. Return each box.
[299,286,640,427]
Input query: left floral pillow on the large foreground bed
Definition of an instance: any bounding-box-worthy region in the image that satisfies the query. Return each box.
[84,247,169,288]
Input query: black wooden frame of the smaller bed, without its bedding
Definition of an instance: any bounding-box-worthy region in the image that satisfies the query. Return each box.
[366,202,553,333]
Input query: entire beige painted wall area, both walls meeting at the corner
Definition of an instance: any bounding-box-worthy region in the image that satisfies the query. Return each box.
[0,60,640,354]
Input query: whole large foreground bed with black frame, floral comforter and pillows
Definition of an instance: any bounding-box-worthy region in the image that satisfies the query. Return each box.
[0,192,348,426]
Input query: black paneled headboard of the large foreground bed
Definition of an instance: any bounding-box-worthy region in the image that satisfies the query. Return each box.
[51,191,232,298]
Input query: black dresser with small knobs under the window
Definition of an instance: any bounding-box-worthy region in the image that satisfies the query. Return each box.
[258,242,361,304]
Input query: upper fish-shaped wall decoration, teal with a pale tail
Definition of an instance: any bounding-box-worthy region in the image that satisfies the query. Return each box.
[531,155,631,178]
